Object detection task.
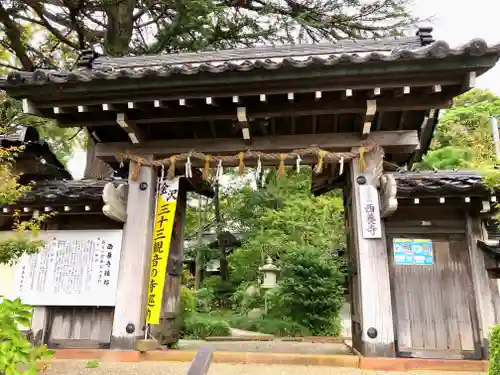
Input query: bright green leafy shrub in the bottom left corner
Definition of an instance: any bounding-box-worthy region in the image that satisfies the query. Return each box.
[0,296,54,375]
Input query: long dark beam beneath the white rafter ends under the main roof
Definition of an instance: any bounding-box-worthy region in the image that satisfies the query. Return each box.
[56,95,452,127]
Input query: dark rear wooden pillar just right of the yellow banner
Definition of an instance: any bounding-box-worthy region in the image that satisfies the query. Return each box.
[151,178,187,345]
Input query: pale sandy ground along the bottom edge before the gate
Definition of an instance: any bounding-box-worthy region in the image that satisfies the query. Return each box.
[45,360,483,375]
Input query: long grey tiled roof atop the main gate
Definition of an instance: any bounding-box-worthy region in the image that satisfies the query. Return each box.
[4,37,500,88]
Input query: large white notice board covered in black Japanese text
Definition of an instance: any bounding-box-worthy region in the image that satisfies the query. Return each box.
[13,230,122,306]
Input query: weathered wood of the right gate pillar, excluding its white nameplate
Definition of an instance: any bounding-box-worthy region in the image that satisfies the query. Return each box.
[349,148,395,357]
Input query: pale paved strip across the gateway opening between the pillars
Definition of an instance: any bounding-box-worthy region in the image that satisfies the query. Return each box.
[179,340,351,354]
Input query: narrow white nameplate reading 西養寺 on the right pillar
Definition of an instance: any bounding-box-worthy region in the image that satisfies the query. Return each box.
[359,185,382,238]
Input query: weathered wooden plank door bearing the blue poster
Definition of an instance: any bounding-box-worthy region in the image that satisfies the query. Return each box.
[388,234,481,359]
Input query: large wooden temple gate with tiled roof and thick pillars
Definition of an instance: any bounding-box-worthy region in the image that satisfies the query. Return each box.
[1,29,500,358]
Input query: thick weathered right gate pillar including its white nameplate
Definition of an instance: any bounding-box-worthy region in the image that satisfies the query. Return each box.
[346,150,395,357]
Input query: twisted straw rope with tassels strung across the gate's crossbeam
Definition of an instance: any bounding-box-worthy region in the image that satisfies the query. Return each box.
[117,143,383,181]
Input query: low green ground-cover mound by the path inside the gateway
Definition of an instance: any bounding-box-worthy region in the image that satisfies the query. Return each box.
[229,315,311,337]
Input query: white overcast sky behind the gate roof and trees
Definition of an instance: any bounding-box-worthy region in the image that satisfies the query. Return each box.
[68,0,500,179]
